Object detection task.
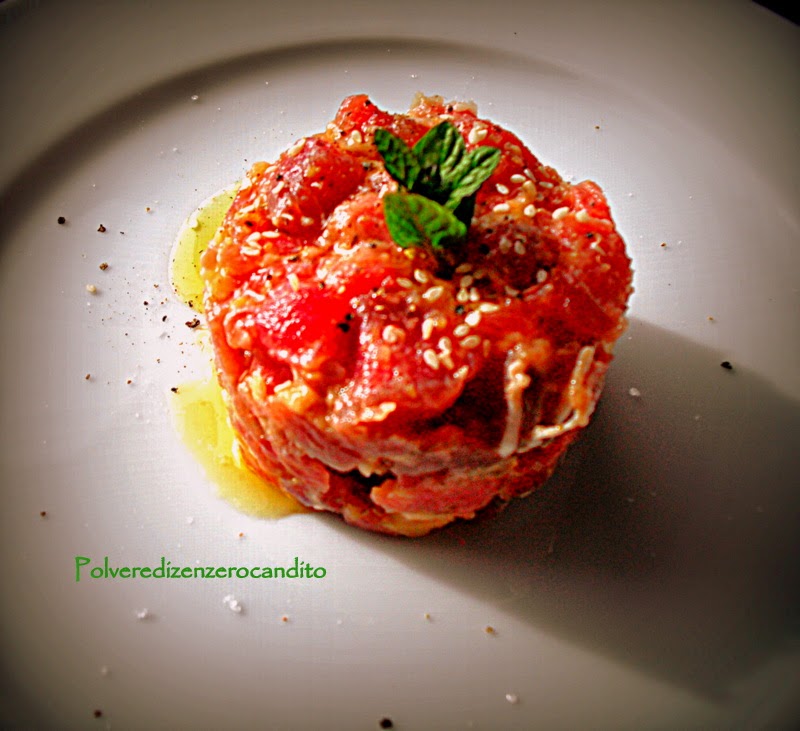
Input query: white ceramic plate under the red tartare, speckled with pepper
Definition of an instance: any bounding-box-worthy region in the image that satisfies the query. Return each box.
[0,0,800,730]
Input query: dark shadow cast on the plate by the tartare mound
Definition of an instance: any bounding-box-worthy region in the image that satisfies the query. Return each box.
[324,320,800,699]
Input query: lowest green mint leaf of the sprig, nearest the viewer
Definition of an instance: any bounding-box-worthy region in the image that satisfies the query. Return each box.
[383,192,467,249]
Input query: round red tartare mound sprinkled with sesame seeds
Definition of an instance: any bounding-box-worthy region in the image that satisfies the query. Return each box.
[202,95,631,536]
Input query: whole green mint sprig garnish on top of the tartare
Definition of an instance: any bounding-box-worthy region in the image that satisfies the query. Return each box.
[375,121,500,258]
